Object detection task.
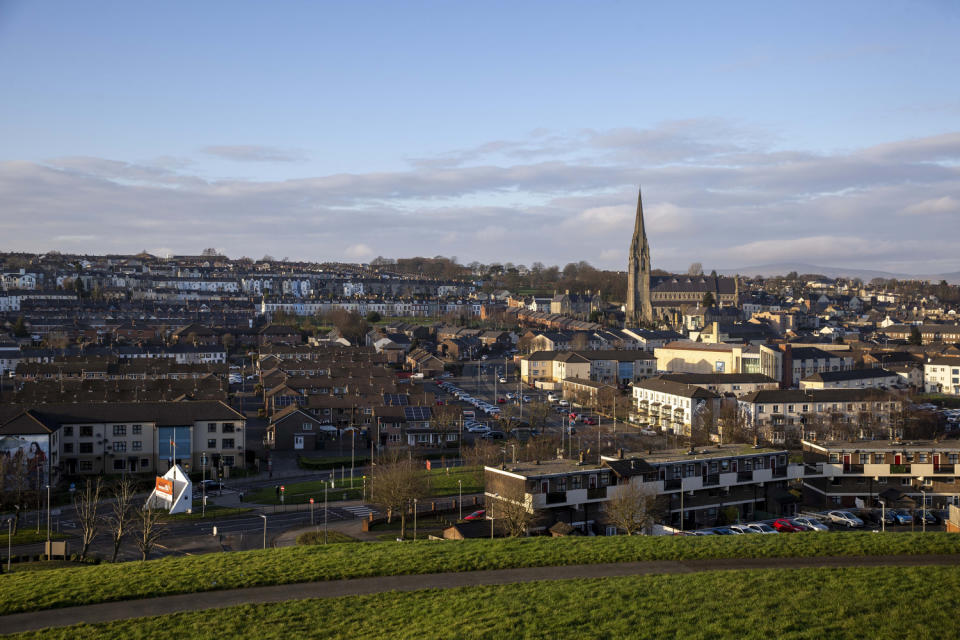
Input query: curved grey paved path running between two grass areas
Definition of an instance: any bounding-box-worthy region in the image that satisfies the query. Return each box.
[0,555,960,633]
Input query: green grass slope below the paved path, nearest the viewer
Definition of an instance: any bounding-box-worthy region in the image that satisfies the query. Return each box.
[9,567,960,640]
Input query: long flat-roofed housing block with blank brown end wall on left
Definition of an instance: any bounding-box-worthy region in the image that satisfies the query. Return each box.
[484,445,803,535]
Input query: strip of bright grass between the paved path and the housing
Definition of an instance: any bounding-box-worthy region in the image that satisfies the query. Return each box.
[0,532,960,614]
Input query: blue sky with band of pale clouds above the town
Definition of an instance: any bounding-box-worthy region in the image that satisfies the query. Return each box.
[0,0,960,274]
